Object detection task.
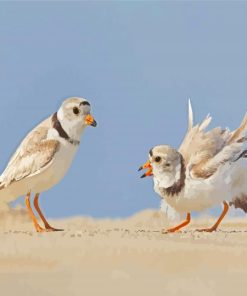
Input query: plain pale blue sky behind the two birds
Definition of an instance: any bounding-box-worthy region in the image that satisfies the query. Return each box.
[0,1,247,217]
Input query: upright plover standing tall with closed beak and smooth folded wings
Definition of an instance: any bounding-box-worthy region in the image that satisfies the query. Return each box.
[0,97,97,232]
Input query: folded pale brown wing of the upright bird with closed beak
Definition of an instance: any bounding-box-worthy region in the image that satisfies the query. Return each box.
[0,120,60,188]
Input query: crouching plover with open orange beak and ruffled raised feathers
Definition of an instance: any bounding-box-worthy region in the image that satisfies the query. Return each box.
[140,101,247,233]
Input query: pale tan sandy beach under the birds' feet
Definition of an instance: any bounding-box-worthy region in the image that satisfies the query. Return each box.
[0,210,247,296]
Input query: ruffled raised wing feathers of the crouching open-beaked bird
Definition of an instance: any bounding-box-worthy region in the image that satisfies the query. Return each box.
[179,102,247,178]
